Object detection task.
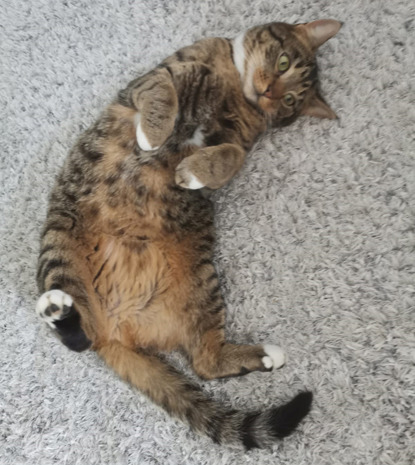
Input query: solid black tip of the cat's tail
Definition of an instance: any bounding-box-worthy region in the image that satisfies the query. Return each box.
[270,391,313,438]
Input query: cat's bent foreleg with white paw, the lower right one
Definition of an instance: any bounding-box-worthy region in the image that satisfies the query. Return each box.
[175,143,246,189]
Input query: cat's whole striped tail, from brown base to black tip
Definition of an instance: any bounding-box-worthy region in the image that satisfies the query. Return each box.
[98,342,312,449]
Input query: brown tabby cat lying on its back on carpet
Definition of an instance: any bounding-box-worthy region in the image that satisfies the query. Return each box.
[36,20,341,449]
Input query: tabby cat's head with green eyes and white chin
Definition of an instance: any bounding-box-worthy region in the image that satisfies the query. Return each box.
[233,19,341,125]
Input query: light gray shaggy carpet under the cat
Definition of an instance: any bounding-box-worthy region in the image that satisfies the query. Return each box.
[0,0,415,465]
